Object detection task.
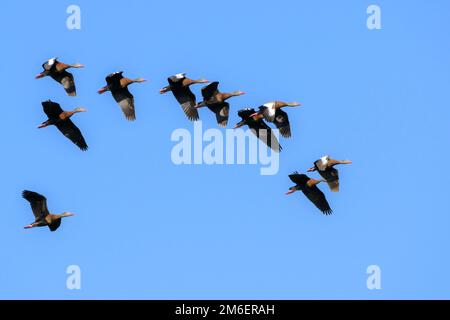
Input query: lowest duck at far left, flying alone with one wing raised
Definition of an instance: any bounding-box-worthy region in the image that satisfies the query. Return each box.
[22,190,74,231]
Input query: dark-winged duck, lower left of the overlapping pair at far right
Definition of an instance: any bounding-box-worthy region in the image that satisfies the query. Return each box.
[286,172,333,215]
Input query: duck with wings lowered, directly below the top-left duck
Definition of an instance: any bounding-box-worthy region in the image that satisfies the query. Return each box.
[38,100,88,151]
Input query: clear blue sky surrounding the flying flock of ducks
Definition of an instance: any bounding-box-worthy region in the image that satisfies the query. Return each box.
[0,0,450,299]
